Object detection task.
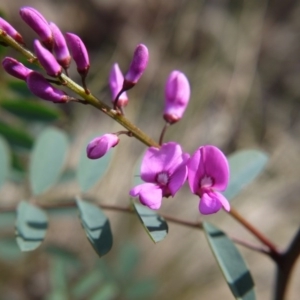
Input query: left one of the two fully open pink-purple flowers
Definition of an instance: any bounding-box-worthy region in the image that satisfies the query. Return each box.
[129,142,189,209]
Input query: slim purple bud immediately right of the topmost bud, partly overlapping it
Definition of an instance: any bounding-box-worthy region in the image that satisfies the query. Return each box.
[49,22,71,69]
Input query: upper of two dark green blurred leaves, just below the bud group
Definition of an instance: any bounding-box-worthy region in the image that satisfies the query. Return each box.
[0,100,62,122]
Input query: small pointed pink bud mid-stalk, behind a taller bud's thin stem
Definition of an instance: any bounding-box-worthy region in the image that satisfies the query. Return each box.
[109,63,128,107]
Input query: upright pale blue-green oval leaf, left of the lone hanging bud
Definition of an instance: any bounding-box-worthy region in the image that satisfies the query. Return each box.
[29,128,68,195]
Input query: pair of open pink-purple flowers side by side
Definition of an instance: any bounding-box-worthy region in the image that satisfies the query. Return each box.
[129,142,230,215]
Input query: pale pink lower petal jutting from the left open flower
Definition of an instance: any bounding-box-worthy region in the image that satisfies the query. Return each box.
[129,183,162,209]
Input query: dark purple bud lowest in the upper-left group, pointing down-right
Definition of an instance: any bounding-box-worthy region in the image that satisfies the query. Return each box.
[26,71,70,103]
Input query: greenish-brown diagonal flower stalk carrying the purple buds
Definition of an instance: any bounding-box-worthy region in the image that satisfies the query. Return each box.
[0,29,159,147]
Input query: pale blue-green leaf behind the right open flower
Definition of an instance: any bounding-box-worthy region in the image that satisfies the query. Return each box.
[224,150,269,200]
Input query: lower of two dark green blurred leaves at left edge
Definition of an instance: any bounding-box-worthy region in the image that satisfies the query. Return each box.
[0,122,33,149]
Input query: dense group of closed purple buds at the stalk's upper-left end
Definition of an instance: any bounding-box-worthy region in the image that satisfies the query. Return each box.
[0,6,89,103]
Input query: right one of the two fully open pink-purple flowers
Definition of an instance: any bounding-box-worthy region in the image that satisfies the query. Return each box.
[187,145,230,215]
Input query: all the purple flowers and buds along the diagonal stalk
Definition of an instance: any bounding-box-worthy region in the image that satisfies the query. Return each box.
[0,6,230,214]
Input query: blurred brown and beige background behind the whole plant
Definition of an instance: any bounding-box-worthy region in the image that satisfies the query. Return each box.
[0,0,300,300]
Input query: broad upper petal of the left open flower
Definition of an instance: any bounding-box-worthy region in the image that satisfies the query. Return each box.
[141,142,182,182]
